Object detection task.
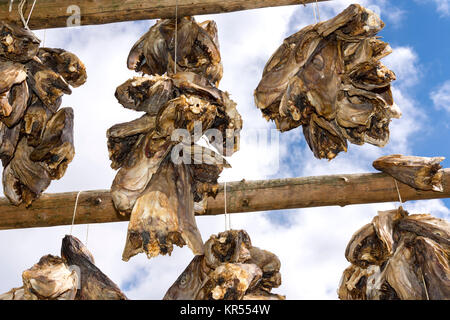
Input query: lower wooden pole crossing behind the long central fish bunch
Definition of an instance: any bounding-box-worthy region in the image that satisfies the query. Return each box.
[0,169,450,230]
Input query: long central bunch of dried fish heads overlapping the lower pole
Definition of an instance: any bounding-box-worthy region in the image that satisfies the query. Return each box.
[107,17,242,261]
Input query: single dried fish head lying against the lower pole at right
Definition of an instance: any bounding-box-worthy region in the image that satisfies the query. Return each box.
[373,154,445,192]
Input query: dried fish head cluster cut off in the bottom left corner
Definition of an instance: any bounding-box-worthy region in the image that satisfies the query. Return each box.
[0,236,127,300]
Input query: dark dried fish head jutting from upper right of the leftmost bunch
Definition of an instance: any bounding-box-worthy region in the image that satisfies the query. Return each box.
[37,48,87,88]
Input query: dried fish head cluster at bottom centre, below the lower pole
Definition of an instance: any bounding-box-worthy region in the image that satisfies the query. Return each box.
[164,230,285,300]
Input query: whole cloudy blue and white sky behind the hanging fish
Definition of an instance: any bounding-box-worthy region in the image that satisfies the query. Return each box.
[0,0,450,299]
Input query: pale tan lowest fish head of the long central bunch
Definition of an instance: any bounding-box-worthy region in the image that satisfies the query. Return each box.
[122,158,203,261]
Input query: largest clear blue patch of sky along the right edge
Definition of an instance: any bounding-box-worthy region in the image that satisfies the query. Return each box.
[380,0,450,169]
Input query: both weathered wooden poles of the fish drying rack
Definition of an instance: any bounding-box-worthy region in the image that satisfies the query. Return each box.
[0,0,450,230]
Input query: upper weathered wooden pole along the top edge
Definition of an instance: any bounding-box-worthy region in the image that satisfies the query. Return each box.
[0,0,328,29]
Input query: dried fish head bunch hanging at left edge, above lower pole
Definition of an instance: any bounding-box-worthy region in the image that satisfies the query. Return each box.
[0,21,87,206]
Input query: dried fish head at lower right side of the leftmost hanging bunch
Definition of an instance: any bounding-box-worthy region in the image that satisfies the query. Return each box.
[30,108,75,180]
